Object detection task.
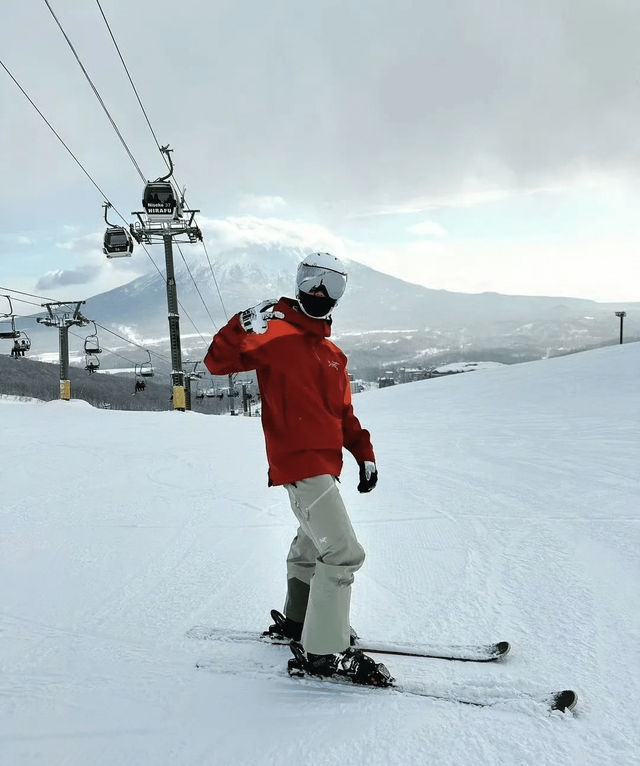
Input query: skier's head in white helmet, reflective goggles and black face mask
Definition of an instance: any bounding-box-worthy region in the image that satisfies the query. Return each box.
[296,253,347,319]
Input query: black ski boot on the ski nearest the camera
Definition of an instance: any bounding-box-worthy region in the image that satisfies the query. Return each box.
[288,641,393,686]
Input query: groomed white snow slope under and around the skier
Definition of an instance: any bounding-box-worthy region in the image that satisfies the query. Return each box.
[0,344,640,766]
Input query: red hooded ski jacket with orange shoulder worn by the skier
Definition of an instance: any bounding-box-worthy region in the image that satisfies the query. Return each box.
[204,298,375,484]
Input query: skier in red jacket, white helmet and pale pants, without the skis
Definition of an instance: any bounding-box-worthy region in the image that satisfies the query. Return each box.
[204,253,391,686]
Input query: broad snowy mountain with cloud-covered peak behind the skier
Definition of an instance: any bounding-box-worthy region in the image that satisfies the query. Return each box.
[17,245,640,377]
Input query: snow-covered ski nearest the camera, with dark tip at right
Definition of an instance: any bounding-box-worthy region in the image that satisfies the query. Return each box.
[196,659,578,713]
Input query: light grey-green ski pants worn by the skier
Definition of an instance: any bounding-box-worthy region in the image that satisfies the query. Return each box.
[285,474,364,654]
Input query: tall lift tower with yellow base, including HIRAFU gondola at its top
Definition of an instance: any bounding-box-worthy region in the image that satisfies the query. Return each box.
[130,146,202,411]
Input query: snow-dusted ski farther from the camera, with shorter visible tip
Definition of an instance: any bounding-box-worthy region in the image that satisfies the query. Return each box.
[186,625,511,662]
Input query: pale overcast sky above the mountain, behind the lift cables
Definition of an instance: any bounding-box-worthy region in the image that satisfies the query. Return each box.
[0,0,640,311]
